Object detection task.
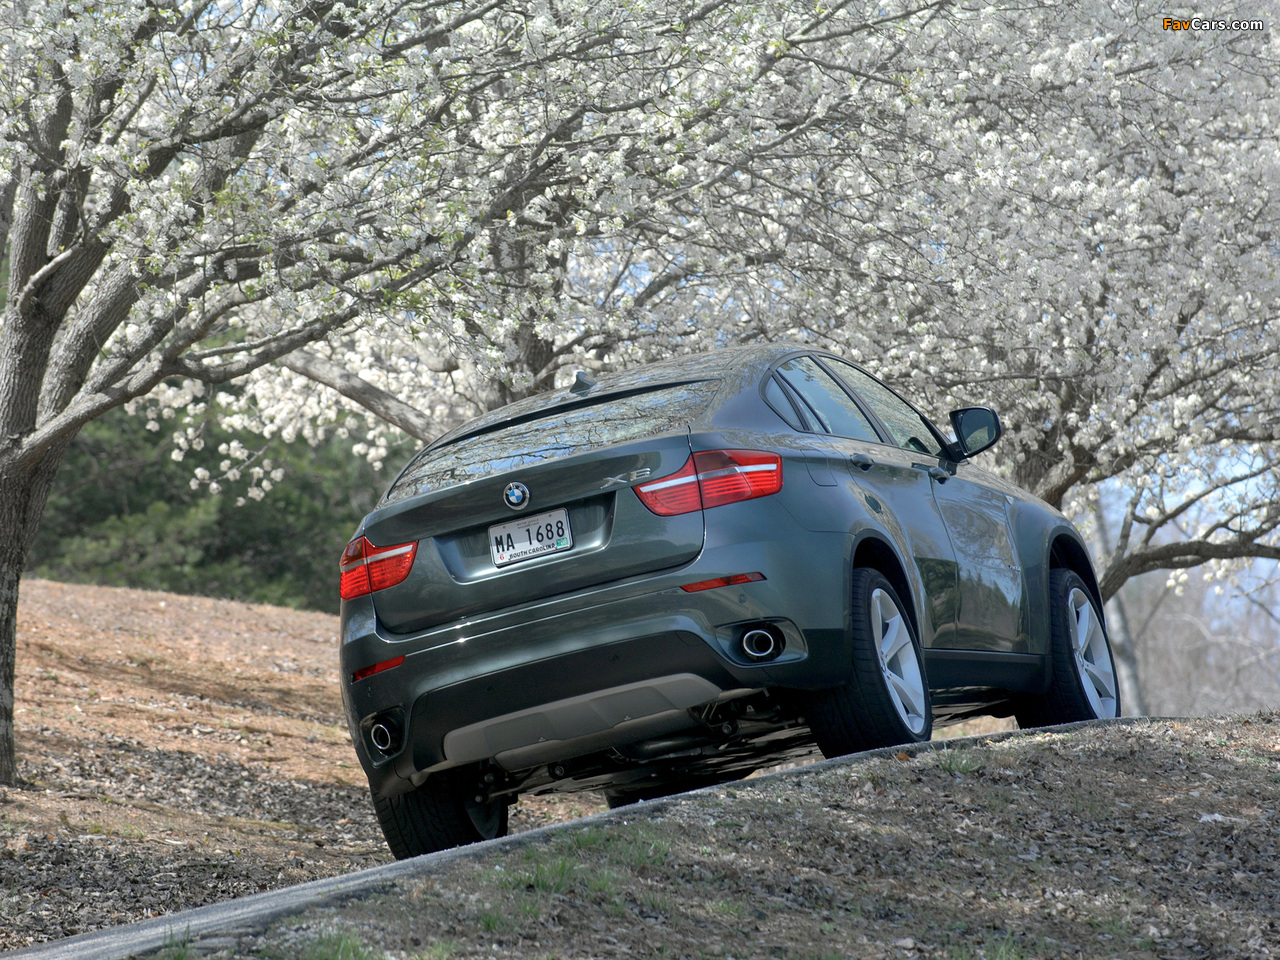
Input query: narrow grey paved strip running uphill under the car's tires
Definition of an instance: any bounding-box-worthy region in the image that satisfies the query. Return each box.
[3,717,1162,960]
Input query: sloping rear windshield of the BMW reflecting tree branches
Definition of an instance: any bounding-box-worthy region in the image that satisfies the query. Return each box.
[383,380,719,503]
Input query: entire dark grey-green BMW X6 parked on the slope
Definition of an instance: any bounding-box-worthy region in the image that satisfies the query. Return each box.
[340,344,1120,858]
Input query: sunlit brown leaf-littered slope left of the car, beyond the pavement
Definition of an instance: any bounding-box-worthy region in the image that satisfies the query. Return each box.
[0,580,604,950]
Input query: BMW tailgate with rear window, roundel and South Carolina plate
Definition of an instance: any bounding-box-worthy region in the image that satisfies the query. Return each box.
[362,378,703,634]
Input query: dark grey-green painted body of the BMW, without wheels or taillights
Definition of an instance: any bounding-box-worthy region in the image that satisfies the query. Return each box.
[340,346,1101,800]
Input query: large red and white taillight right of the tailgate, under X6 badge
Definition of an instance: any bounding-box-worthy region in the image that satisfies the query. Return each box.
[632,451,782,517]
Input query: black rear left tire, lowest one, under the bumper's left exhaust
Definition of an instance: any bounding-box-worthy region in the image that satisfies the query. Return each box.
[374,769,507,860]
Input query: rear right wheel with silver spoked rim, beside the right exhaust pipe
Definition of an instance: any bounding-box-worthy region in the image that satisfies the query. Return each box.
[808,567,933,756]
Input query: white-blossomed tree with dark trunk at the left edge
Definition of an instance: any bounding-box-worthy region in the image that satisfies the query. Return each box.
[0,0,962,782]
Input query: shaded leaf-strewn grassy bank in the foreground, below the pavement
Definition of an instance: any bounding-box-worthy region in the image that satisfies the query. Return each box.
[230,713,1280,960]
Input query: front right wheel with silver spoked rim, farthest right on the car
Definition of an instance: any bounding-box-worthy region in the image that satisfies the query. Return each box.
[1014,568,1120,728]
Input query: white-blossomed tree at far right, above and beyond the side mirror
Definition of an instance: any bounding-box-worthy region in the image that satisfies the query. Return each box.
[826,4,1280,609]
